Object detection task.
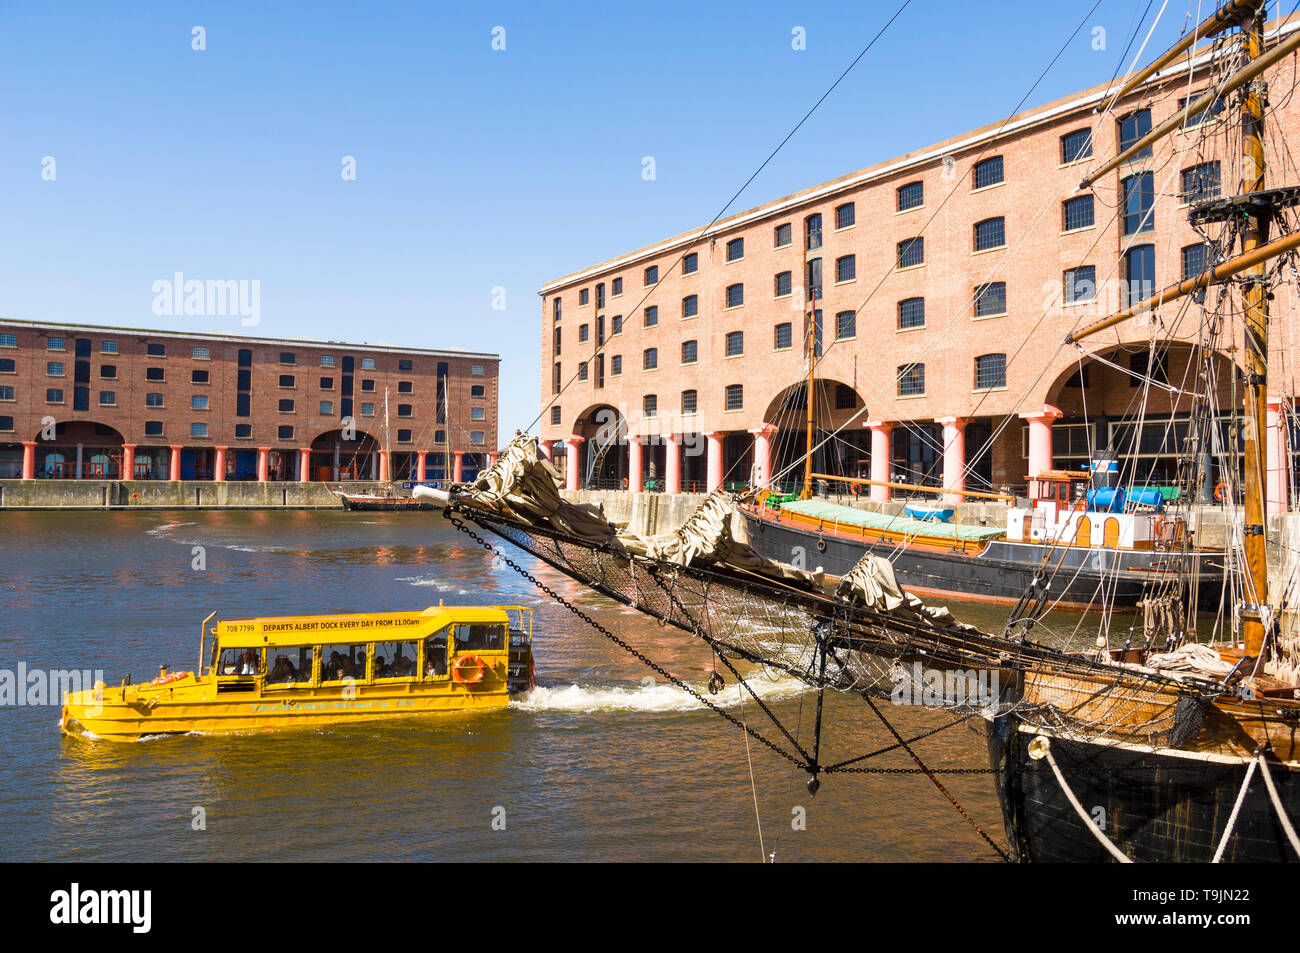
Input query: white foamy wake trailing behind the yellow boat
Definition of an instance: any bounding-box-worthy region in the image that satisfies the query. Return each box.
[510,679,807,714]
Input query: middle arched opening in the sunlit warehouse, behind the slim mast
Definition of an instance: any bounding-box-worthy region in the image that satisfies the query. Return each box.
[764,380,871,493]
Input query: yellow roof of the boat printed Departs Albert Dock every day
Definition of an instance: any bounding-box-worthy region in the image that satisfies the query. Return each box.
[216,606,510,649]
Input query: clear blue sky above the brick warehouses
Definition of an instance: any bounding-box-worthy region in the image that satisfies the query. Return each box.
[0,0,1242,437]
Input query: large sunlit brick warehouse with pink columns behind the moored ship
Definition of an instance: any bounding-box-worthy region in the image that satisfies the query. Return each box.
[540,18,1300,510]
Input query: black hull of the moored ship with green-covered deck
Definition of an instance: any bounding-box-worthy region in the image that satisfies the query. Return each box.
[745,511,1223,611]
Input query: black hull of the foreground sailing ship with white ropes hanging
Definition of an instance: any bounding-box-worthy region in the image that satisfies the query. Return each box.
[988,715,1300,863]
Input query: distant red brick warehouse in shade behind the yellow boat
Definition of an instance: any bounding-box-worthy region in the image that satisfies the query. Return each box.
[0,320,499,481]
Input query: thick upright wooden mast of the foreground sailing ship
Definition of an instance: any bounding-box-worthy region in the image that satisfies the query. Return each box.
[1242,3,1268,659]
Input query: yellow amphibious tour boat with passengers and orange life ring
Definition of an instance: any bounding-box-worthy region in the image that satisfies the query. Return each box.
[61,606,533,741]
